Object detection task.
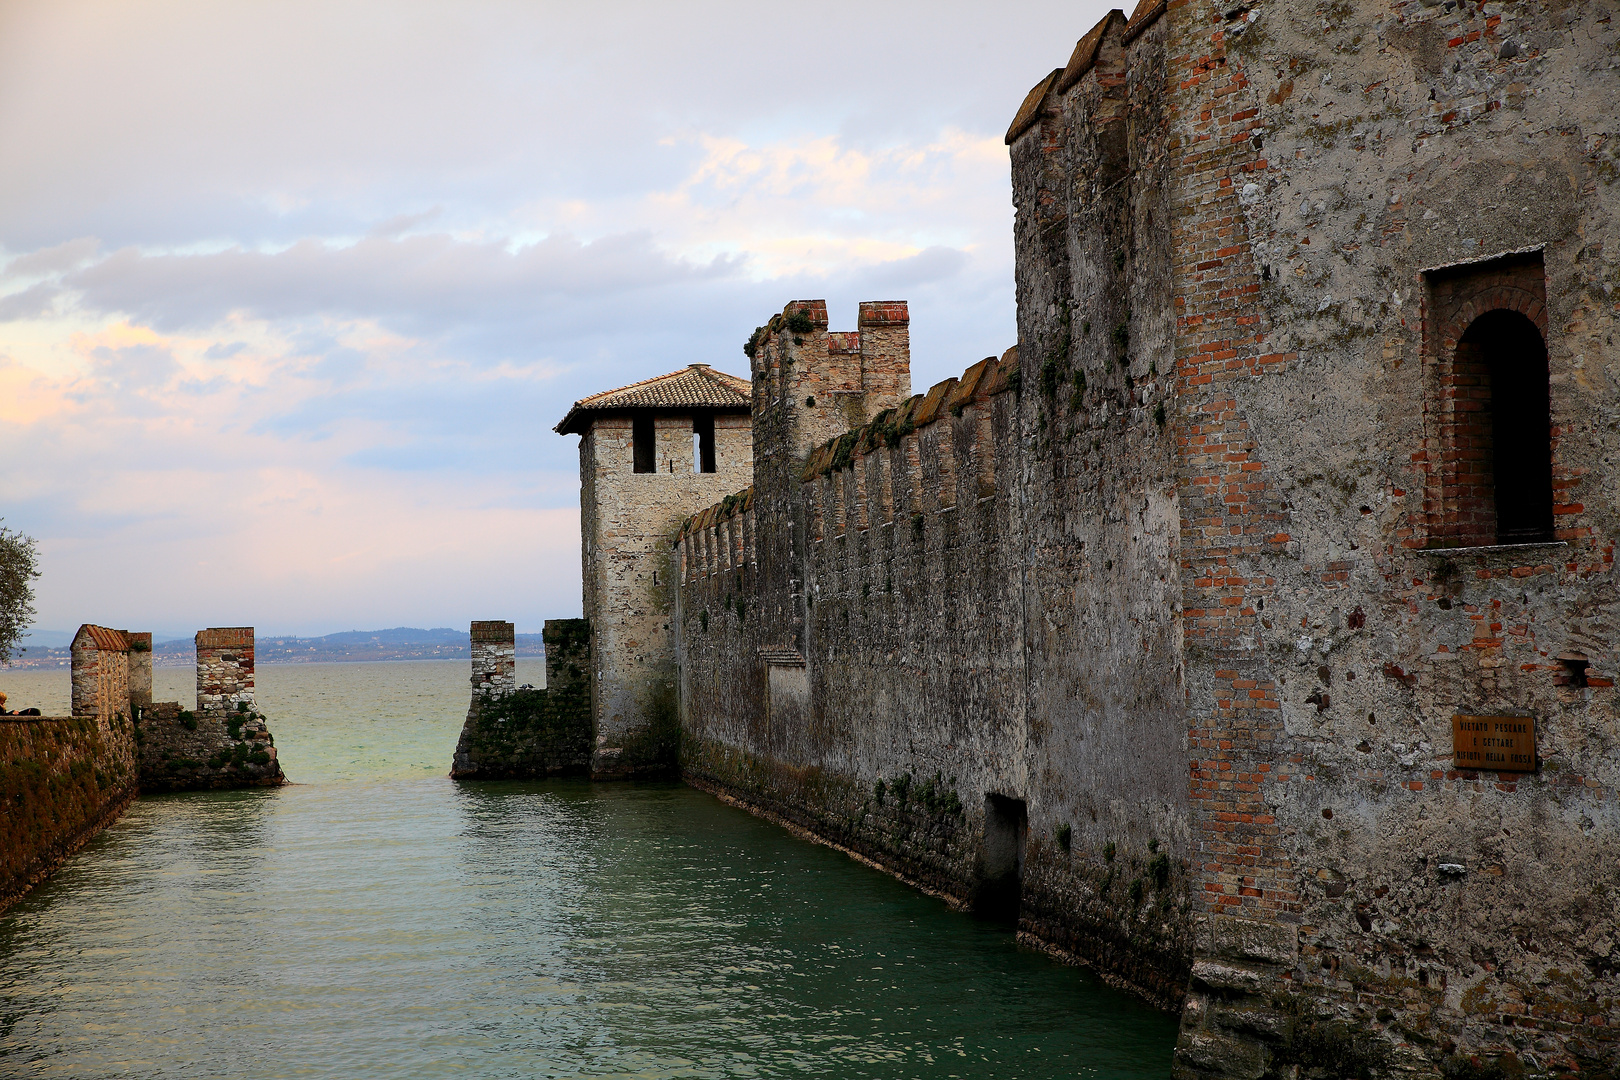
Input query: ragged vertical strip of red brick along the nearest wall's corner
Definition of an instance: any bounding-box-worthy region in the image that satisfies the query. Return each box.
[1170,5,1298,918]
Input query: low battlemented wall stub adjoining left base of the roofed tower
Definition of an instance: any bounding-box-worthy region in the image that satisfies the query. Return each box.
[450,619,596,780]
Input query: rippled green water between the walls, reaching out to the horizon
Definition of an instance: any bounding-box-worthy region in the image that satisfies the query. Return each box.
[0,661,1175,1080]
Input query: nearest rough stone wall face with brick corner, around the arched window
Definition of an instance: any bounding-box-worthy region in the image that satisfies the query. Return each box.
[1134,0,1620,1075]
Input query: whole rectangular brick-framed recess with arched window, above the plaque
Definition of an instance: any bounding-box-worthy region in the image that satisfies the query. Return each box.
[1422,251,1557,547]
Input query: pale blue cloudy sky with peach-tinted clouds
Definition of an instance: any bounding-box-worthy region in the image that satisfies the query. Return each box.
[0,0,1108,636]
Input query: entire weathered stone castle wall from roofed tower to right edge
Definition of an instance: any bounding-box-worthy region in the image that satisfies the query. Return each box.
[664,0,1620,1077]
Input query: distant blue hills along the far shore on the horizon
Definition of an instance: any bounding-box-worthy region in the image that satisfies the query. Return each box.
[3,627,546,667]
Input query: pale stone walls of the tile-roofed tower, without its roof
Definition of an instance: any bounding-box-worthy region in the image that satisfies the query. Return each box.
[580,401,753,777]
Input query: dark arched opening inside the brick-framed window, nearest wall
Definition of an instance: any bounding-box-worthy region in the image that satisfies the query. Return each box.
[1456,311,1552,544]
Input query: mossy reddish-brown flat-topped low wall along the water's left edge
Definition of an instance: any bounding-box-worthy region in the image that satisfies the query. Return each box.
[0,716,136,912]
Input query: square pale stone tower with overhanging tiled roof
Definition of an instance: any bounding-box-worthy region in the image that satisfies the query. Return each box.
[556,364,753,777]
